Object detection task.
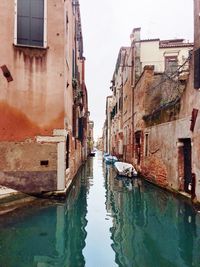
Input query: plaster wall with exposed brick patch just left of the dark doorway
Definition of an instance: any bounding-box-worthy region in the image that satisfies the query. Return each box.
[142,118,191,190]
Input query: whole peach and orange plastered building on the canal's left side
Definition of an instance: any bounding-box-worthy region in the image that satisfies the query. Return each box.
[0,0,88,193]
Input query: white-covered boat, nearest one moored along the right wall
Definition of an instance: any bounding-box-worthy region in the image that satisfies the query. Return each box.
[114,161,138,178]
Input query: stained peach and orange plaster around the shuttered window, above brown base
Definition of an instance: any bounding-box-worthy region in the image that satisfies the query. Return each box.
[0,0,65,141]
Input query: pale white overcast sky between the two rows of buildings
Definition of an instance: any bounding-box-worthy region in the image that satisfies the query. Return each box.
[79,0,193,139]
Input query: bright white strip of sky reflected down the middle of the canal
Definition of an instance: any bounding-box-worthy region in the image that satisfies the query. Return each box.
[83,153,117,267]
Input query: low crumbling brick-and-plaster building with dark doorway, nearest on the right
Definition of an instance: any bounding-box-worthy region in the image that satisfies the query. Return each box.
[133,1,200,201]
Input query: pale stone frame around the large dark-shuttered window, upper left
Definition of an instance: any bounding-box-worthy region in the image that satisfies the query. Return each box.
[14,0,47,49]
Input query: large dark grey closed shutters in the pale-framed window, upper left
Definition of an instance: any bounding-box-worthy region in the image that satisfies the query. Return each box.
[17,0,44,47]
